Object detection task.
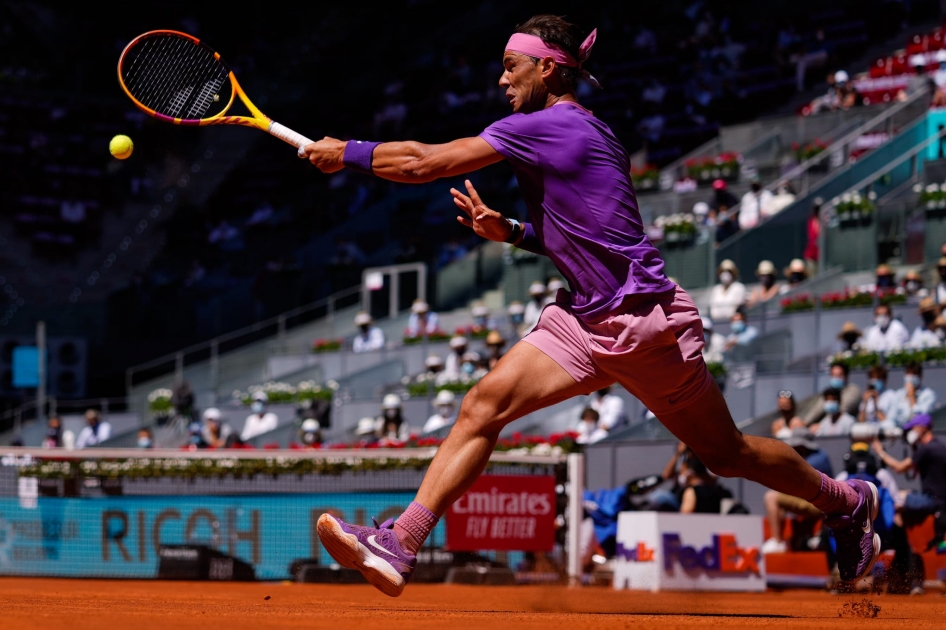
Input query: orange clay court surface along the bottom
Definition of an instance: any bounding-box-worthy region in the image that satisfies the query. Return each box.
[0,578,946,630]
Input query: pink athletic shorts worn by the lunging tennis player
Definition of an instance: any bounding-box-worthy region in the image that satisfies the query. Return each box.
[523,287,713,417]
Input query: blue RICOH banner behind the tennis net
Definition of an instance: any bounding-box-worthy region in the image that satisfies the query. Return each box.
[0,492,444,580]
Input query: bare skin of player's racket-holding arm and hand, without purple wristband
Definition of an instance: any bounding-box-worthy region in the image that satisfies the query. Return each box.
[300,137,503,184]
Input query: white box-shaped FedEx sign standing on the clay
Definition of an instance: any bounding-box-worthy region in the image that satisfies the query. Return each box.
[614,512,765,591]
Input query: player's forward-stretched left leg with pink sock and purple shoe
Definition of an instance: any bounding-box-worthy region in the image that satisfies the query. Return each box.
[318,343,594,597]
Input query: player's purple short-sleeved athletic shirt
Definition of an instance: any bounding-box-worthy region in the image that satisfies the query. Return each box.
[480,102,674,323]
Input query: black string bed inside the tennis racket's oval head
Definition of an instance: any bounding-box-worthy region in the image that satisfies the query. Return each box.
[122,35,229,120]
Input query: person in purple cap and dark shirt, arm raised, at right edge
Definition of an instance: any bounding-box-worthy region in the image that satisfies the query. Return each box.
[874,414,946,542]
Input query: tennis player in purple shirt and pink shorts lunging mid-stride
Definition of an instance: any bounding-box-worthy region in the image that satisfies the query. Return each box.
[300,15,880,596]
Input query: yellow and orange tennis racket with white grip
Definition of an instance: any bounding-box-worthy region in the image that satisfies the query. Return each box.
[118,31,312,148]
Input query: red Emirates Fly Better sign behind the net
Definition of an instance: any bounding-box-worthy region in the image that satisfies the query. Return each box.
[447,475,555,551]
